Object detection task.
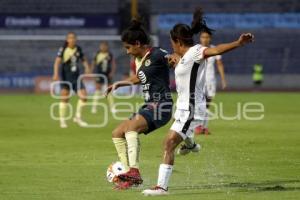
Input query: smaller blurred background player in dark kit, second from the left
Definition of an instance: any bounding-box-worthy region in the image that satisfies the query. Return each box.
[92,42,116,113]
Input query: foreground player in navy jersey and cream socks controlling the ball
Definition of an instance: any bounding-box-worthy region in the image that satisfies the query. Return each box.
[107,20,173,189]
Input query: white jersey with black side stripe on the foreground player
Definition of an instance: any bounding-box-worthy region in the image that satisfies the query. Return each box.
[175,44,207,118]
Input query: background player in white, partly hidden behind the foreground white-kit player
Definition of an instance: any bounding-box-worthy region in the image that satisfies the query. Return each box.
[195,25,227,134]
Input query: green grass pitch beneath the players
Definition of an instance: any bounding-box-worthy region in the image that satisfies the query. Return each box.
[0,93,300,200]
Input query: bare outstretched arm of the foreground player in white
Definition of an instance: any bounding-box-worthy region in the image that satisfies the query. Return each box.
[204,33,254,57]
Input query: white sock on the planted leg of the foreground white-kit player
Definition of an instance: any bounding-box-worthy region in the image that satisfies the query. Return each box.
[157,164,173,190]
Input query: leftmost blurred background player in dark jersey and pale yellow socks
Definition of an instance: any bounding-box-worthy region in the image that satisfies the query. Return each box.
[53,32,89,128]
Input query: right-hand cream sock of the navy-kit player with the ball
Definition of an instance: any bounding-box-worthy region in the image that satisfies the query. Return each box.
[125,131,140,168]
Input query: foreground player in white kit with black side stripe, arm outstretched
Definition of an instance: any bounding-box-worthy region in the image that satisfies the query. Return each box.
[143,10,253,196]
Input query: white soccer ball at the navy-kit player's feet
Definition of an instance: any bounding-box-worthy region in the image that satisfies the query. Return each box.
[106,161,127,184]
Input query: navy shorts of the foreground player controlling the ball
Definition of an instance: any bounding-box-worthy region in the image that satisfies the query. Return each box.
[129,101,173,135]
